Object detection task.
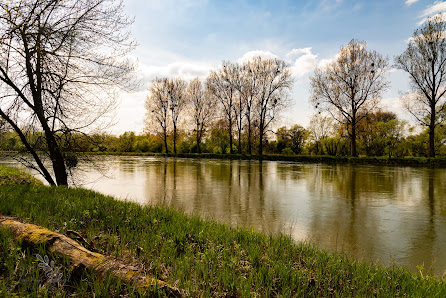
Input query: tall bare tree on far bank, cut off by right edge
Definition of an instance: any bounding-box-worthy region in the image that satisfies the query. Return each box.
[395,14,446,157]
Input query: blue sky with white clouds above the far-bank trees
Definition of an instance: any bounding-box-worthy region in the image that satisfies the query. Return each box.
[110,0,446,134]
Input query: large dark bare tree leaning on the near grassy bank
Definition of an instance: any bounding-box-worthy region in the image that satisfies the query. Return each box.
[0,0,134,185]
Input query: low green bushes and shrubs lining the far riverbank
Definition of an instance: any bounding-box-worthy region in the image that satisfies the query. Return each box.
[0,110,446,157]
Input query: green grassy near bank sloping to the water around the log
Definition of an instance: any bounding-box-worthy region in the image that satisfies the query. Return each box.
[0,168,446,297]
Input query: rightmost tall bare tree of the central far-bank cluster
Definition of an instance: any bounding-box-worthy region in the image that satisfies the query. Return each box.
[253,57,293,155]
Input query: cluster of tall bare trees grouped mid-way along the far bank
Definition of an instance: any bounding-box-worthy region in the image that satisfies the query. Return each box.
[146,57,293,155]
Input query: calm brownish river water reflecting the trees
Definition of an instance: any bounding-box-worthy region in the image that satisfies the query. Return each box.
[3,156,446,276]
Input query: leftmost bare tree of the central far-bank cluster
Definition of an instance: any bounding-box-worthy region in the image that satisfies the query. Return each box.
[145,78,170,154]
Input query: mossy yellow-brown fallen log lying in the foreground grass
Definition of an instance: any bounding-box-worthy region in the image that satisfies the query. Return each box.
[0,215,182,297]
